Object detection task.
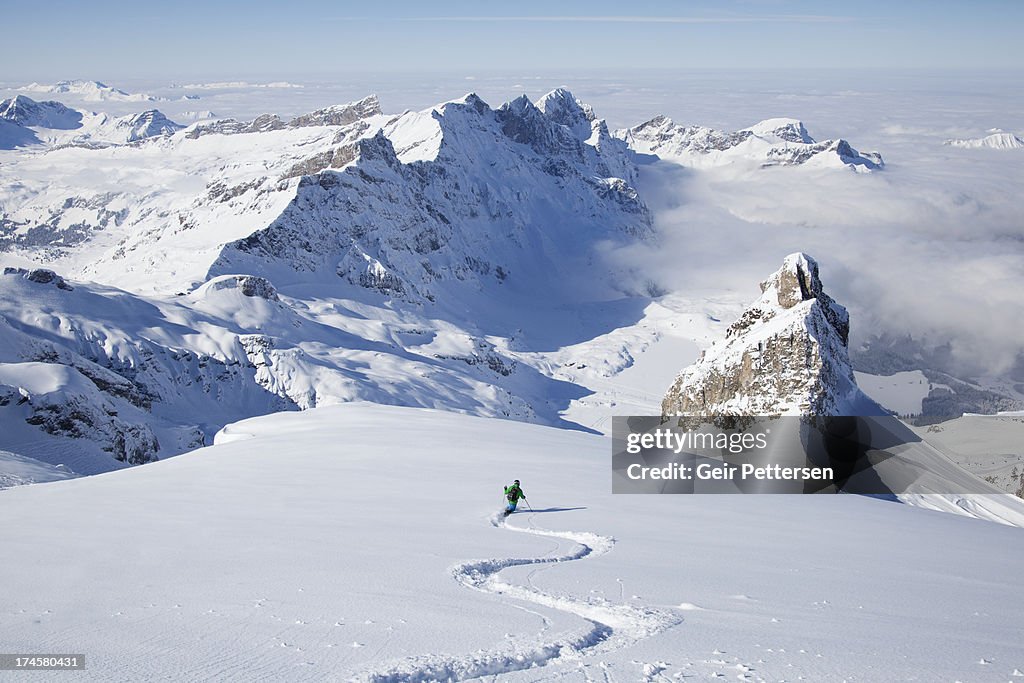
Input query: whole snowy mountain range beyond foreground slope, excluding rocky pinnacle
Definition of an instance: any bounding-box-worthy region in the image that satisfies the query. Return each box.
[0,89,1019,491]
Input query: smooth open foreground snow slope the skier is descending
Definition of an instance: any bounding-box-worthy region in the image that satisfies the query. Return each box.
[0,404,1024,682]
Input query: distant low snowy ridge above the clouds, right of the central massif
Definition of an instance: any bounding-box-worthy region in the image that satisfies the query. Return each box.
[615,116,884,173]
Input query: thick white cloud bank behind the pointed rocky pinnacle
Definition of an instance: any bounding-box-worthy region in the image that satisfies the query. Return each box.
[613,151,1024,375]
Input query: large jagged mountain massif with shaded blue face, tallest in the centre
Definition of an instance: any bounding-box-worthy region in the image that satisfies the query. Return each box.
[207,93,650,303]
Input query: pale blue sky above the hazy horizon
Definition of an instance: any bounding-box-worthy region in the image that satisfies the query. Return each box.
[0,0,1024,80]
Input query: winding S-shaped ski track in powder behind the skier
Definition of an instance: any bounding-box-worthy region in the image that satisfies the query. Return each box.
[354,513,683,683]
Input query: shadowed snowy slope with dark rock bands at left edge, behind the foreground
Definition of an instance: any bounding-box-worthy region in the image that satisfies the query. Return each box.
[0,268,295,474]
